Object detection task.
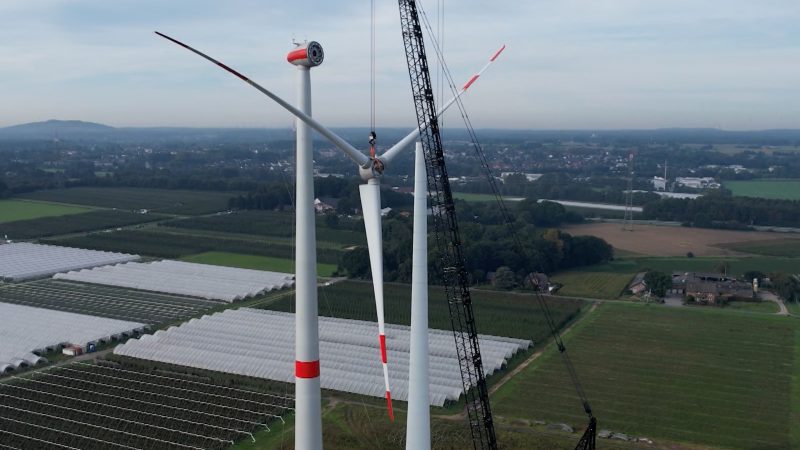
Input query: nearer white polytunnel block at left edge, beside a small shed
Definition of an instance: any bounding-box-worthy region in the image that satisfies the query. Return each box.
[0,303,146,372]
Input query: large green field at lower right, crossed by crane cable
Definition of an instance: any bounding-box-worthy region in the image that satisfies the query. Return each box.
[492,303,800,450]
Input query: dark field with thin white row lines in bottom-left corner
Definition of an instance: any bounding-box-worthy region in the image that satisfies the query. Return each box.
[0,362,293,449]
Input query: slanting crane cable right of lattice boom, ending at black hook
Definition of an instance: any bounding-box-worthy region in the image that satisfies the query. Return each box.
[418,1,597,450]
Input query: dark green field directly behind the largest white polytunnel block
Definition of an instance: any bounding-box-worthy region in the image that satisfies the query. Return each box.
[266,280,586,344]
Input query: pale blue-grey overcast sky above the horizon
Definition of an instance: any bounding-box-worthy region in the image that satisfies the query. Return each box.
[0,0,800,130]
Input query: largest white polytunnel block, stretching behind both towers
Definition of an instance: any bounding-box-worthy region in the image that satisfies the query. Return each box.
[114,308,531,406]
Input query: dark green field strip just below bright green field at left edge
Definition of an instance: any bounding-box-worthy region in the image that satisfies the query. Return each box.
[0,209,166,239]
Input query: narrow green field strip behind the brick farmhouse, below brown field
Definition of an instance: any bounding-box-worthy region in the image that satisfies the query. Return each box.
[579,256,800,276]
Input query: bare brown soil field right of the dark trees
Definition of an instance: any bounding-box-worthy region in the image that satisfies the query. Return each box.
[564,223,800,256]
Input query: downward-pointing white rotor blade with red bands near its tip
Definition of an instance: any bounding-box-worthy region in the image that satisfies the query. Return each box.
[358,178,394,420]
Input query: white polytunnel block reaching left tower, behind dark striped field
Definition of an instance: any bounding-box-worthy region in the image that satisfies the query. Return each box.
[54,260,294,302]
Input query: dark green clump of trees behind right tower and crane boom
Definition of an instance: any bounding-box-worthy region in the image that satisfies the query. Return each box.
[339,202,614,284]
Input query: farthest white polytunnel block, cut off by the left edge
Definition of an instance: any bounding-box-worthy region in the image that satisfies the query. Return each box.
[0,242,139,281]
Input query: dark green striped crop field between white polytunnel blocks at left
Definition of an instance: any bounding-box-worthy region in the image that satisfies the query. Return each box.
[0,279,225,324]
